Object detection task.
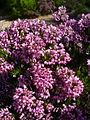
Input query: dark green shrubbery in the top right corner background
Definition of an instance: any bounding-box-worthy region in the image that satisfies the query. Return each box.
[54,0,90,14]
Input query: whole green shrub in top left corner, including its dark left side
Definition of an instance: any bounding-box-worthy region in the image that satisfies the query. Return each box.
[0,0,37,18]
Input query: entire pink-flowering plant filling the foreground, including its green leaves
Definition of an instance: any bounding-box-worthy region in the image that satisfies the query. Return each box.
[0,6,90,120]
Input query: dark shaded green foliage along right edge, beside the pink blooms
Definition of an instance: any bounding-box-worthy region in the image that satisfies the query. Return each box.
[66,42,90,92]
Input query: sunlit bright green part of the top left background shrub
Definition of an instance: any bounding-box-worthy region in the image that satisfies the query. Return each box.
[10,0,37,17]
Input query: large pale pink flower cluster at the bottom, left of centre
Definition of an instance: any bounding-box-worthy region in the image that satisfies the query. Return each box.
[13,86,44,120]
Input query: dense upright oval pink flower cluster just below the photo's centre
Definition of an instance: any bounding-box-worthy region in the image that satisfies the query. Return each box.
[32,67,55,99]
